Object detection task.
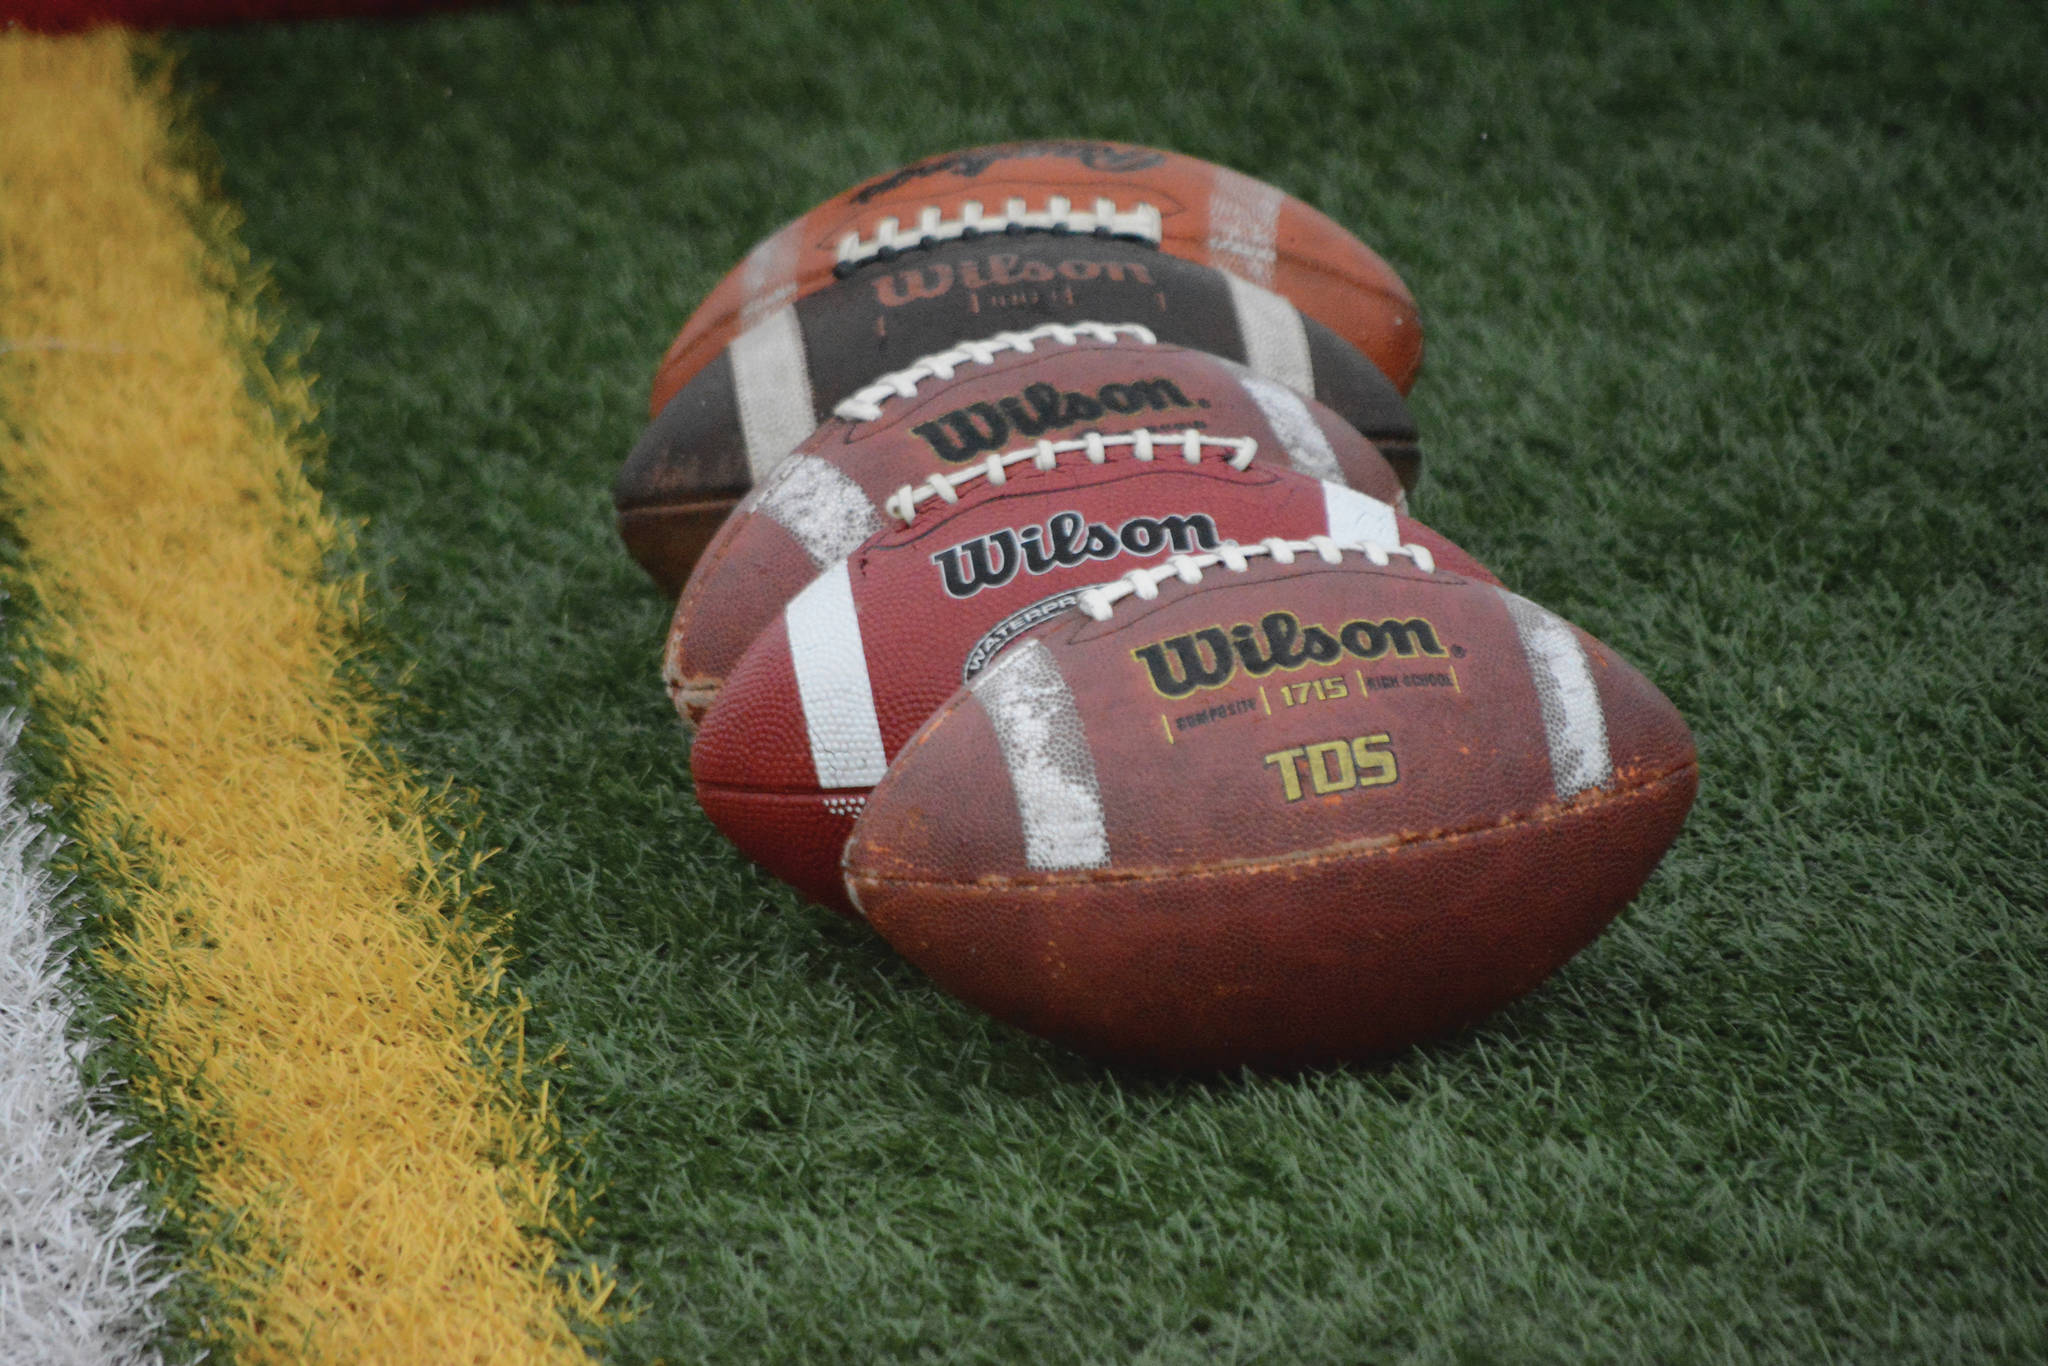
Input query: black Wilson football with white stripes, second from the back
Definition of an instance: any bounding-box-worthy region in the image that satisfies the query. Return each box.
[612,236,1419,592]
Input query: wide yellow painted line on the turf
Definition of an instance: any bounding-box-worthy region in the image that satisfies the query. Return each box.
[0,33,610,1362]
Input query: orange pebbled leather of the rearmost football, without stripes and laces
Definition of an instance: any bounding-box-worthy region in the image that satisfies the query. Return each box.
[647,141,1423,416]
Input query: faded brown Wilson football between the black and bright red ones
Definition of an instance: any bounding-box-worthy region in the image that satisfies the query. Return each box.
[662,324,1405,721]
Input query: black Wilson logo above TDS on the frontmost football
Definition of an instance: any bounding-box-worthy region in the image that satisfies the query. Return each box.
[1130,612,1446,696]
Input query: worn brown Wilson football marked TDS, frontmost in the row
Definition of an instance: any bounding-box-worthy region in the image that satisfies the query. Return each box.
[846,541,1698,1069]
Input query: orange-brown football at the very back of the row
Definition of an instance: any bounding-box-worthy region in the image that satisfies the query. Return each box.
[647,141,1421,416]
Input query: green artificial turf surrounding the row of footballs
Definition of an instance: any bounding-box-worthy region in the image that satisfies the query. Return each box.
[184,2,2048,1362]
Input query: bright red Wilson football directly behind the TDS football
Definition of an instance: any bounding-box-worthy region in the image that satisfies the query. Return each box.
[690,450,1485,909]
